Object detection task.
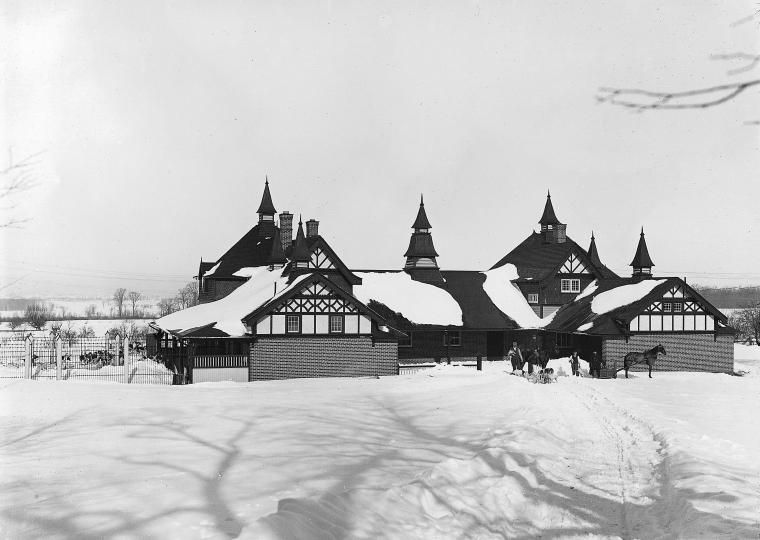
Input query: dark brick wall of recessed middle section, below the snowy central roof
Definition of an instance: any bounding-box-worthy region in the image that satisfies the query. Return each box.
[398,330,487,364]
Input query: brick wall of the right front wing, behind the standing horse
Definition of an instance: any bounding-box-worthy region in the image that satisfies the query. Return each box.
[602,334,734,373]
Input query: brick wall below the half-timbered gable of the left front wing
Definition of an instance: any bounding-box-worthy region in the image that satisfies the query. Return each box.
[249,336,398,381]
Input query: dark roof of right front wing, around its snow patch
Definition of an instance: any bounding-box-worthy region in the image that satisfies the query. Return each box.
[546,277,733,335]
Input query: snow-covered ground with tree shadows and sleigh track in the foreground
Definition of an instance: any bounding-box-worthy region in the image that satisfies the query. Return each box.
[0,347,760,539]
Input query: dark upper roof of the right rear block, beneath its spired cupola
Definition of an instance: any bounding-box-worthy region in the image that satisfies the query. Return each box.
[491,232,617,281]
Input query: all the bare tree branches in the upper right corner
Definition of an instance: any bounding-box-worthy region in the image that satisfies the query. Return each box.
[597,10,760,120]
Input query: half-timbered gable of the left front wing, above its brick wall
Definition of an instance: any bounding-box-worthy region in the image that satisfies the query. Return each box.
[243,274,383,336]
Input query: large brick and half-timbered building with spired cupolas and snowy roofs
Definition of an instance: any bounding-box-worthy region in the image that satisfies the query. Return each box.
[153,181,733,382]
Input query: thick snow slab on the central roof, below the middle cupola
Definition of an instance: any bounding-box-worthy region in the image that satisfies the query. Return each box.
[354,272,462,326]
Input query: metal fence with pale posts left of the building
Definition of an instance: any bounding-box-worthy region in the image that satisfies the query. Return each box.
[0,336,177,385]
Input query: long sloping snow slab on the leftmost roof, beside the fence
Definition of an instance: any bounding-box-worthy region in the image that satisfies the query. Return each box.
[155,267,308,336]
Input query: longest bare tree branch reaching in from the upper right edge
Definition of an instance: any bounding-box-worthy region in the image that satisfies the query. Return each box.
[596,79,760,112]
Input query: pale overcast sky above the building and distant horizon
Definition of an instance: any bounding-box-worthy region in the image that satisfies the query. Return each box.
[0,0,760,297]
